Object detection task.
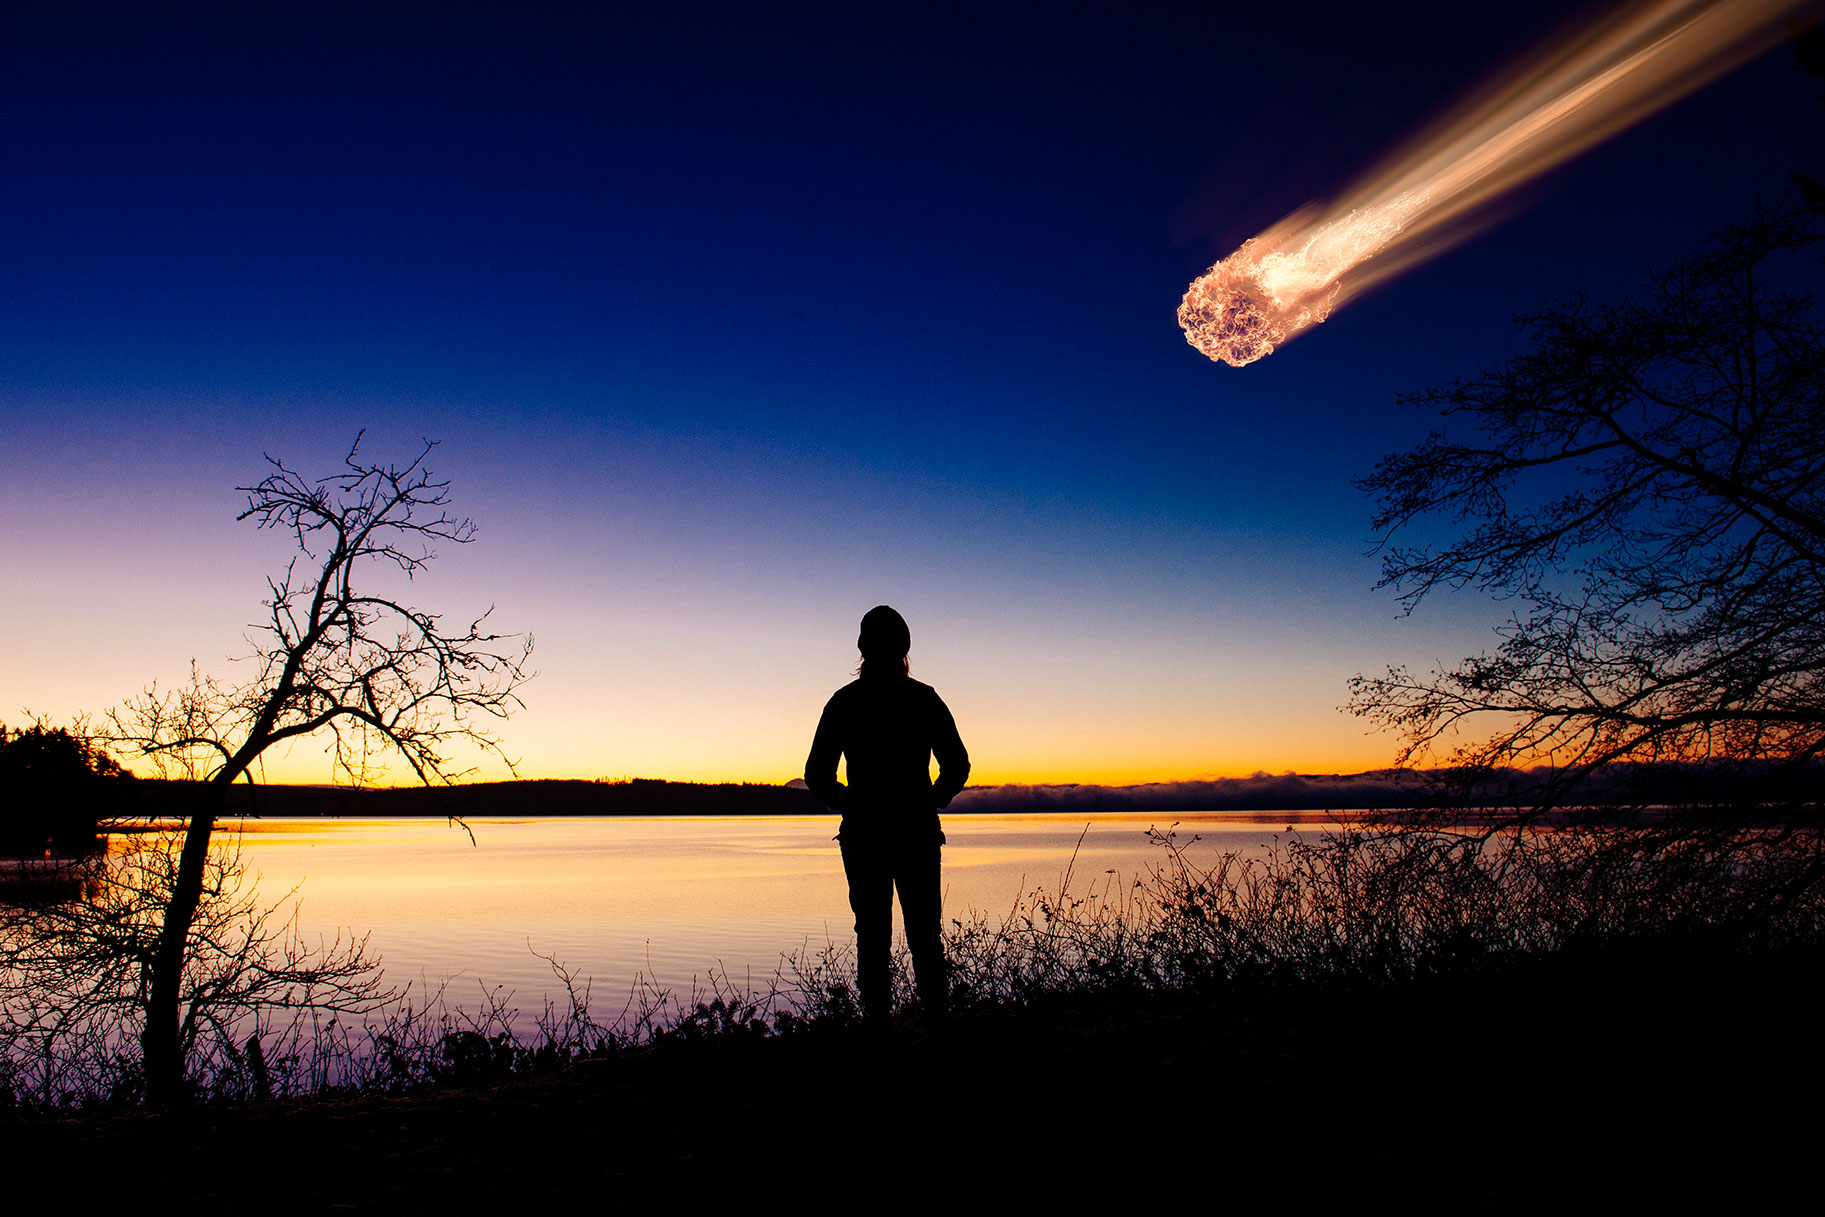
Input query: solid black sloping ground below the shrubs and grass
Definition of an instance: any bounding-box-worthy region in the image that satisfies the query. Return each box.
[0,949,1825,1213]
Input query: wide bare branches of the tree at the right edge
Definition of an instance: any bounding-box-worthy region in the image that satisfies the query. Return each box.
[1349,212,1825,805]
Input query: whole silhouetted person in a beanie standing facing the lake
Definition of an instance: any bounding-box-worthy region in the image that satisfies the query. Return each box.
[805,604,969,1024]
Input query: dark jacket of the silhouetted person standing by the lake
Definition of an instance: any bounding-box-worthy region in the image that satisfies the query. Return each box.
[805,673,969,827]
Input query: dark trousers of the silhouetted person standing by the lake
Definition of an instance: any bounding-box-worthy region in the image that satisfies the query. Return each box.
[838,816,949,1022]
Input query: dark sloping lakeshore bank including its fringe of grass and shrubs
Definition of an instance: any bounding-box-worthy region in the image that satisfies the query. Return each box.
[0,819,1825,1210]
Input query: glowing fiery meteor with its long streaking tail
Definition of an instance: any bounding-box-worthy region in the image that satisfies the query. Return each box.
[1179,0,1803,367]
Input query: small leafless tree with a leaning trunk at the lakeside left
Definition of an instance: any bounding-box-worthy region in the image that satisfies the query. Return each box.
[106,436,531,1102]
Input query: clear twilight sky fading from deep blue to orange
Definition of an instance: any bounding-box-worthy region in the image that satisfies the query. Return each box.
[0,4,1825,781]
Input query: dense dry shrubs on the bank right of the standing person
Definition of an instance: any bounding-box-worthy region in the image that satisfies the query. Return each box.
[949,817,1825,1004]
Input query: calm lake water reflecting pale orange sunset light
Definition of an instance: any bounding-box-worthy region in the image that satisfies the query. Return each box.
[188,812,1327,1014]
